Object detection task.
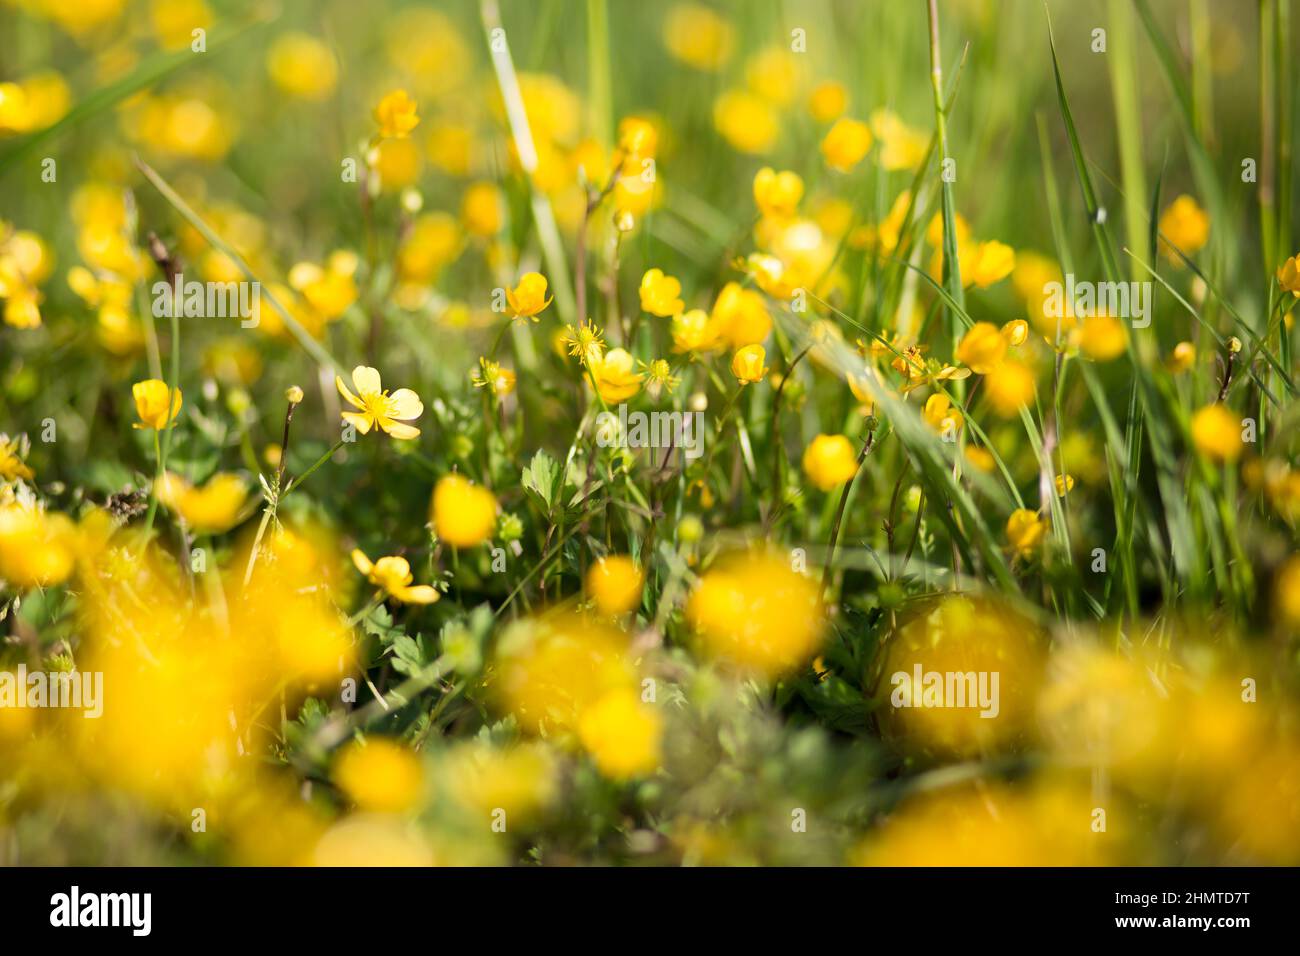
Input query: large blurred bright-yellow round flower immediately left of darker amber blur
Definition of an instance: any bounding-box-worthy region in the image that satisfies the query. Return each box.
[686,554,824,678]
